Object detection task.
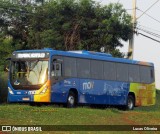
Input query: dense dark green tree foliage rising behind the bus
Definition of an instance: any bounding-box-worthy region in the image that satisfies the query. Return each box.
[0,0,131,69]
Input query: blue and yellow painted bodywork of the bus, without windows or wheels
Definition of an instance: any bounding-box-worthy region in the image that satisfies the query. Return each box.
[8,49,155,106]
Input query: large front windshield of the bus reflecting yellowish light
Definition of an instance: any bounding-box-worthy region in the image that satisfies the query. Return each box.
[10,59,48,88]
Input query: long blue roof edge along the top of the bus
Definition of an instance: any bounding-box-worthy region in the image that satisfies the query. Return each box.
[13,48,154,66]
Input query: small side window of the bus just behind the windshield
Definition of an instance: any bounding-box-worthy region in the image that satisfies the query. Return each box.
[51,62,62,76]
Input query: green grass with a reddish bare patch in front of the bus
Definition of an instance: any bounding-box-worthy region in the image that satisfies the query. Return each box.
[0,71,160,133]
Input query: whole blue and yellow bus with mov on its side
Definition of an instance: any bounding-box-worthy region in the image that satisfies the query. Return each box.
[8,48,156,110]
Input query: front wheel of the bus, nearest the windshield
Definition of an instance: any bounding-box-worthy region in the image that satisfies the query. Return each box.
[67,91,76,108]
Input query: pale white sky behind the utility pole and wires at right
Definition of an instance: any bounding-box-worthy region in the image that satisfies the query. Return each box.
[94,0,160,89]
